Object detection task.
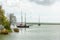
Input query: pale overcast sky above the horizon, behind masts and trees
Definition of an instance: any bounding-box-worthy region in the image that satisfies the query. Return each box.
[0,0,60,23]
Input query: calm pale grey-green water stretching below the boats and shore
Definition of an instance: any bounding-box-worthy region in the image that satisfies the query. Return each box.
[0,25,60,40]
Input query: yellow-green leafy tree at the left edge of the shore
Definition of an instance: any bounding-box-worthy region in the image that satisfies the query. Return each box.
[0,6,10,29]
